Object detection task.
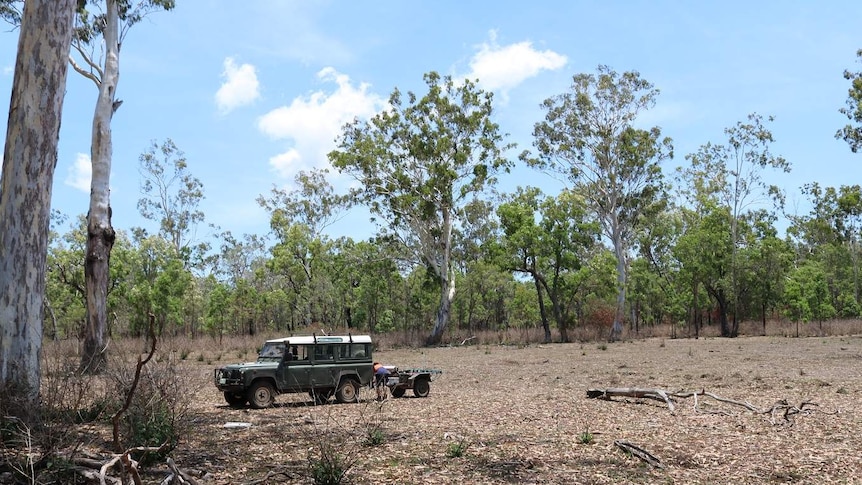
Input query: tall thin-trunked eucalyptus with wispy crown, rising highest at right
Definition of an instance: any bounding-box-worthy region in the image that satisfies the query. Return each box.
[679,114,790,337]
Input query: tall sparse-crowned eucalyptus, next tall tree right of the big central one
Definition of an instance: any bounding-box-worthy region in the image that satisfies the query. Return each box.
[522,66,673,340]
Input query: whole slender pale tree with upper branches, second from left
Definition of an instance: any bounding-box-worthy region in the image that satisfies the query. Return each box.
[69,0,174,373]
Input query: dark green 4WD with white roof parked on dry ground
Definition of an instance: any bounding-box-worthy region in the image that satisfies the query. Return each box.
[214,335,372,409]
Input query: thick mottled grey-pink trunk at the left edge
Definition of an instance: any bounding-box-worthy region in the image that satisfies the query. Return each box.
[0,0,76,421]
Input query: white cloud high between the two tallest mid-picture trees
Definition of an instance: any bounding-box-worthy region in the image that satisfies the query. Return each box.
[466,31,568,97]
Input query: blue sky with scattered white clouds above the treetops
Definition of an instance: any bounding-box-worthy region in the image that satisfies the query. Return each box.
[0,0,862,246]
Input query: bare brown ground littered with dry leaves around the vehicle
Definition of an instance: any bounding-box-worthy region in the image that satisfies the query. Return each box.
[174,336,862,484]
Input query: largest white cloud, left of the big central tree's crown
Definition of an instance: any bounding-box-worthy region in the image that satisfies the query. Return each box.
[258,67,385,179]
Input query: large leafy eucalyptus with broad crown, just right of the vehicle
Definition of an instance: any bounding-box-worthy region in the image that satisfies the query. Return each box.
[329,72,511,344]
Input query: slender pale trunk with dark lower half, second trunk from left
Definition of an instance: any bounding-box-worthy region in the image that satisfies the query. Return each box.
[81,0,120,374]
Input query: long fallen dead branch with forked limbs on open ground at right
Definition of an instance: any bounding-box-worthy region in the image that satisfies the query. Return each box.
[587,387,818,425]
